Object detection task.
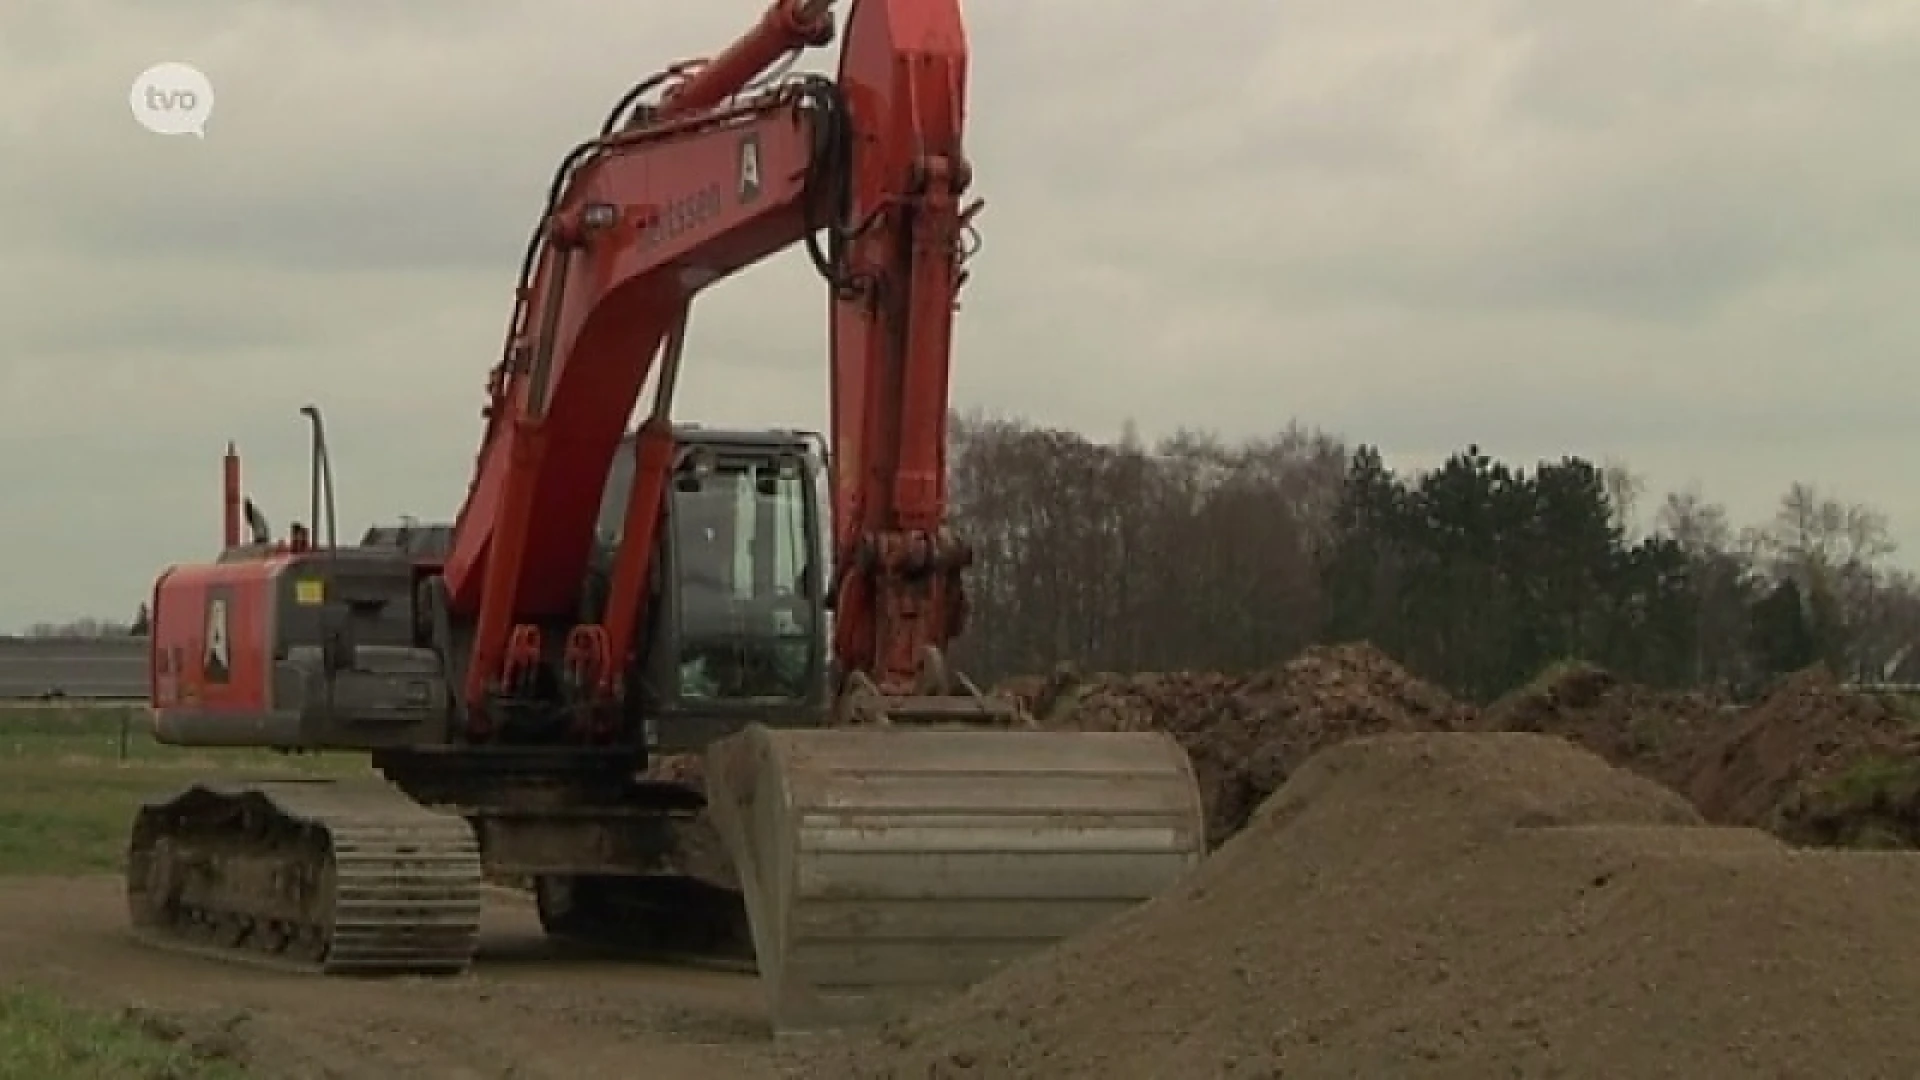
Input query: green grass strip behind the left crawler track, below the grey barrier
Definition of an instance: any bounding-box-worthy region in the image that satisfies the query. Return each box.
[0,707,367,874]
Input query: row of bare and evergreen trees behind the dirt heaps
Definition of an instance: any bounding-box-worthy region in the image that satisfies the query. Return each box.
[948,413,1920,701]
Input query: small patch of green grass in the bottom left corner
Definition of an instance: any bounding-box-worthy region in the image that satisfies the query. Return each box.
[0,988,246,1080]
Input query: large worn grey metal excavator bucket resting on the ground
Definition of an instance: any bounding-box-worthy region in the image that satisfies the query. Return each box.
[707,724,1206,1032]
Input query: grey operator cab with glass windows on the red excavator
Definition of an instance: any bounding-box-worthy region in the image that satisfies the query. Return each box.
[597,425,826,737]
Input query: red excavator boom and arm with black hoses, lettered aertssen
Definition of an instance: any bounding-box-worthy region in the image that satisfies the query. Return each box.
[444,0,977,740]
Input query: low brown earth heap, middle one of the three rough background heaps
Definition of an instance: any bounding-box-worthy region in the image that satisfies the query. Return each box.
[1480,663,1730,790]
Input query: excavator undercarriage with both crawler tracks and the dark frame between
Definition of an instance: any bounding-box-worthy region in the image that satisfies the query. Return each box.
[127,751,753,974]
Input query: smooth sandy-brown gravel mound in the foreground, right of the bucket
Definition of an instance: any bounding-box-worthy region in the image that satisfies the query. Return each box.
[789,732,1920,1080]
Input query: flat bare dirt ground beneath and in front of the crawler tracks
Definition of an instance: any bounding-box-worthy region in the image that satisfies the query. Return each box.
[0,876,774,1080]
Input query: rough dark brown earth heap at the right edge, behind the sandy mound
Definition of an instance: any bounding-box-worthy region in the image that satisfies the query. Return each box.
[1682,669,1920,847]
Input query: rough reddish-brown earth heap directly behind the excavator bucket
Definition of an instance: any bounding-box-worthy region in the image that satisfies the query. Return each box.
[1002,644,1471,846]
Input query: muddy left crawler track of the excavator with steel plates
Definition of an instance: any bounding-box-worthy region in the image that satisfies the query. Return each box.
[127,768,480,974]
